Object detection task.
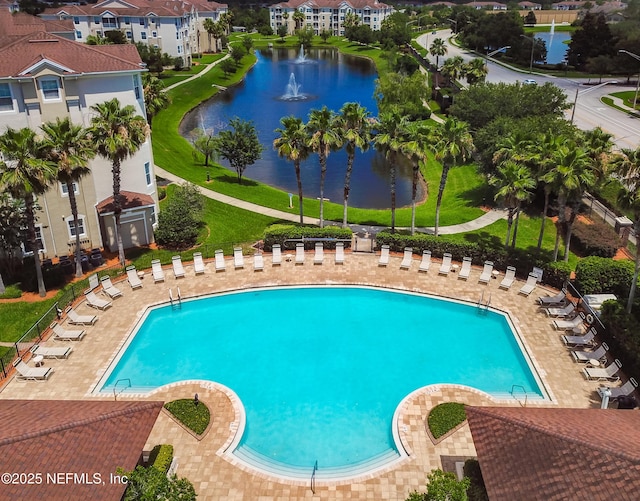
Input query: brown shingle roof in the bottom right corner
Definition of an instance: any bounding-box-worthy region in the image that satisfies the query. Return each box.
[467,407,640,501]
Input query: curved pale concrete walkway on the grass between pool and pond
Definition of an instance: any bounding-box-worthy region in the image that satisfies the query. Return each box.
[155,165,506,235]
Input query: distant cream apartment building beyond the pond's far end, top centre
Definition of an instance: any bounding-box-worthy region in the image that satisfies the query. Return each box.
[269,0,394,36]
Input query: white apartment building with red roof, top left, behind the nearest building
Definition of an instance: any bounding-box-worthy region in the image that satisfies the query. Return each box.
[40,0,227,66]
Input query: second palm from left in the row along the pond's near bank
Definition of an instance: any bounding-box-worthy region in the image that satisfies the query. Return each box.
[306,106,342,228]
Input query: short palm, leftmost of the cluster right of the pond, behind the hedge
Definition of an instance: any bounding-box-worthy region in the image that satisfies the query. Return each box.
[489,160,536,248]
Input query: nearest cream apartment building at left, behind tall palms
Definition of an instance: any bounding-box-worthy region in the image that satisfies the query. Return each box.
[0,11,158,258]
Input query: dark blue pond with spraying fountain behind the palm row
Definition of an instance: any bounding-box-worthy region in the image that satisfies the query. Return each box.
[180,49,423,209]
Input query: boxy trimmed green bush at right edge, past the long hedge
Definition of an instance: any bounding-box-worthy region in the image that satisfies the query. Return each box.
[575,256,634,298]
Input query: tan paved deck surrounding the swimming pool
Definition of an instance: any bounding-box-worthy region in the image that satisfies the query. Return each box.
[0,252,601,501]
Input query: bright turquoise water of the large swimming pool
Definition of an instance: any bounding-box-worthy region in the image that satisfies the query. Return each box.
[102,287,543,467]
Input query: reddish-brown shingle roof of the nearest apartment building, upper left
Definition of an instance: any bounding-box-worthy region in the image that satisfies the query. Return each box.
[0,31,142,77]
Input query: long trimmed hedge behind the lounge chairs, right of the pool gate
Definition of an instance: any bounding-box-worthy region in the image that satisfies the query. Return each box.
[376,230,571,289]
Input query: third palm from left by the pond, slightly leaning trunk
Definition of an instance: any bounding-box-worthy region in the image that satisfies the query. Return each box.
[338,102,372,228]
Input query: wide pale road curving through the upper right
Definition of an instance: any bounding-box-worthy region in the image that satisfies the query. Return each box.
[418,30,640,149]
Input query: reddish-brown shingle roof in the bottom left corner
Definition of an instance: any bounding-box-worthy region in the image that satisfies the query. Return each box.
[0,400,162,501]
